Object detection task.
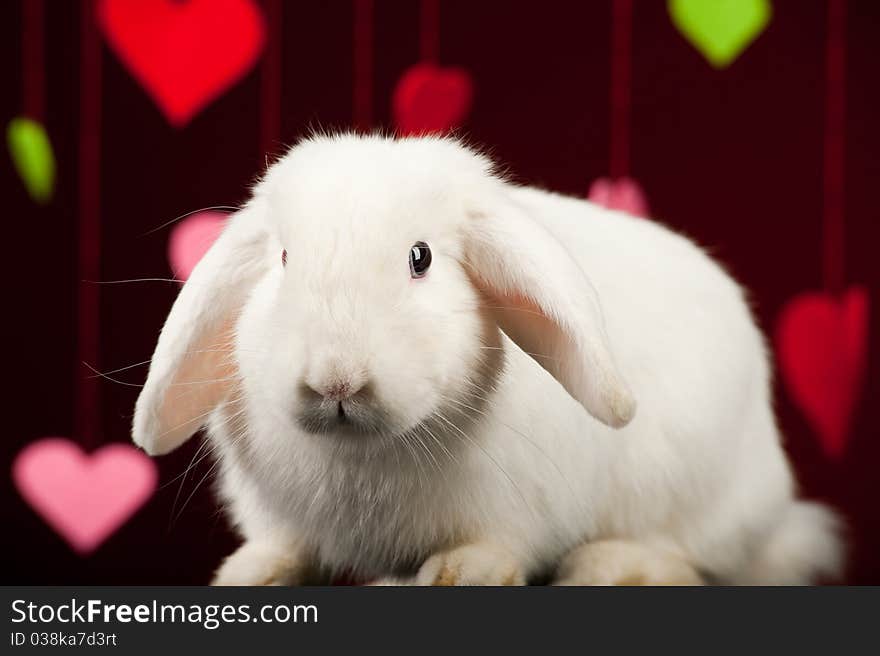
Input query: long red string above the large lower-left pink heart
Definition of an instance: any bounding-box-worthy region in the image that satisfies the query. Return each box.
[76,0,101,447]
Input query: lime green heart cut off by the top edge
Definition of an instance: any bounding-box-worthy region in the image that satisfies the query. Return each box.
[669,0,773,68]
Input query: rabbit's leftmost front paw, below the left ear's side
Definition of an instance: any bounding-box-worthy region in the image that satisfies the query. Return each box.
[211,541,308,585]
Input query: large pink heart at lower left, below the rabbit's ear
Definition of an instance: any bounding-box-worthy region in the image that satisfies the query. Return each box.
[12,437,158,555]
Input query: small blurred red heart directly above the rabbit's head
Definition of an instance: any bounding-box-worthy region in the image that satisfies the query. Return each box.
[394,63,474,134]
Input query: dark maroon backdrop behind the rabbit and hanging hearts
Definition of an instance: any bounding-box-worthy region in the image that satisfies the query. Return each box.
[0,0,880,584]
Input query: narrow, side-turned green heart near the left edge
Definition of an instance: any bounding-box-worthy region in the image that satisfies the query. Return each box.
[6,117,55,204]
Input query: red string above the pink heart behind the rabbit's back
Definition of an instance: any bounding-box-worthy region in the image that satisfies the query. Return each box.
[608,0,633,178]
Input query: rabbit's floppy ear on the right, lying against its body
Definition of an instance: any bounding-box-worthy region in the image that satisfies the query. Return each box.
[465,192,636,428]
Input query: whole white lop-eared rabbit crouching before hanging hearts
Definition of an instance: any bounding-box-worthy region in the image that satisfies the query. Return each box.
[133,135,842,584]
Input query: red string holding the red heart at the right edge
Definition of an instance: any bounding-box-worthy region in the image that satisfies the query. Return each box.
[822,0,846,293]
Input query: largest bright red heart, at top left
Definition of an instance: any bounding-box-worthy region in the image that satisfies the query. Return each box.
[98,0,266,127]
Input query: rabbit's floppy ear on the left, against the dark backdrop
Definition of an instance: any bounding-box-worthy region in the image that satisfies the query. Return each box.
[132,199,268,455]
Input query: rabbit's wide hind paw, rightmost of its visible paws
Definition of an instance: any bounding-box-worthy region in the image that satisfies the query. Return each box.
[554,540,703,585]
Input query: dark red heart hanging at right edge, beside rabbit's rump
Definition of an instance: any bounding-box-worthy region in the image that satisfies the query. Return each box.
[776,287,868,457]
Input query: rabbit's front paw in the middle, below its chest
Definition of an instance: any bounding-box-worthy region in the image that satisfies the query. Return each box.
[416,543,525,585]
